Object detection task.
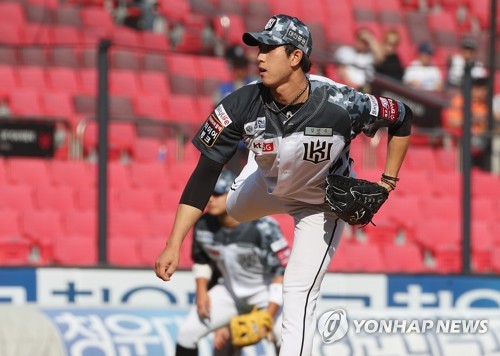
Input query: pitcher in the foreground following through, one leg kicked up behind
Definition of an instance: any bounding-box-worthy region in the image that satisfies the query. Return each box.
[155,14,412,356]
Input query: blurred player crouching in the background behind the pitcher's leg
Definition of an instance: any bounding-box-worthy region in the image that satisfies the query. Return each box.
[176,169,290,356]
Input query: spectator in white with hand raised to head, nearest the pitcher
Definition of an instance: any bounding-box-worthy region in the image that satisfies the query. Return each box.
[334,27,384,91]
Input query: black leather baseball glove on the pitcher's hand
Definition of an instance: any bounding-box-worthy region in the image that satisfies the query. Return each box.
[326,174,389,225]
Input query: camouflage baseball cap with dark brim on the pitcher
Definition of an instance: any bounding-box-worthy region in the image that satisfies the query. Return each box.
[243,14,312,56]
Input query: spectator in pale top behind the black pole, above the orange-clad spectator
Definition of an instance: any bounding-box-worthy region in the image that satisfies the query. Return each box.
[447,37,485,88]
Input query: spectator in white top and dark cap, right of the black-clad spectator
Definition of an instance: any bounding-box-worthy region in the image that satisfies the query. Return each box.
[403,42,443,91]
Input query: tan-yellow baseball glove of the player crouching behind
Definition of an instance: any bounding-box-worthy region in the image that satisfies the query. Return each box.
[229,308,274,347]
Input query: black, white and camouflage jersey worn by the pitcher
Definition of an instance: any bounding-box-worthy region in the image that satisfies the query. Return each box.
[193,75,406,204]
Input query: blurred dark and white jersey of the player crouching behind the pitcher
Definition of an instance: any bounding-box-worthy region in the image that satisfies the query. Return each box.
[191,214,290,298]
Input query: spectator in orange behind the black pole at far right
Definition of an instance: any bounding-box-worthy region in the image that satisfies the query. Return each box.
[443,76,500,168]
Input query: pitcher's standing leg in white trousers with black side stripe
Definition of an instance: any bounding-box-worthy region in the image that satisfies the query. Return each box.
[280,206,345,356]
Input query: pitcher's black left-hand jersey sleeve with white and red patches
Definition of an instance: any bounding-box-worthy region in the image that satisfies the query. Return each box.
[192,92,246,164]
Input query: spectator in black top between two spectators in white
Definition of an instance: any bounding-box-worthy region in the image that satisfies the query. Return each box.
[375,29,404,81]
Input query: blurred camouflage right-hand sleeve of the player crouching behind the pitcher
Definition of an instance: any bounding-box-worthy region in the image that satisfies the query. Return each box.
[257,217,290,276]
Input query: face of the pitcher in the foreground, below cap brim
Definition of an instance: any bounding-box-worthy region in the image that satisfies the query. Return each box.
[257,44,292,88]
